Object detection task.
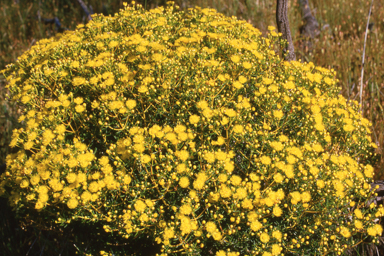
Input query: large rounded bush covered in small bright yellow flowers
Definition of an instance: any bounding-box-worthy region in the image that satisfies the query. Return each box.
[0,2,384,256]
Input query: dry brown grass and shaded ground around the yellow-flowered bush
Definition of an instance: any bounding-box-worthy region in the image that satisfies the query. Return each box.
[0,0,384,255]
